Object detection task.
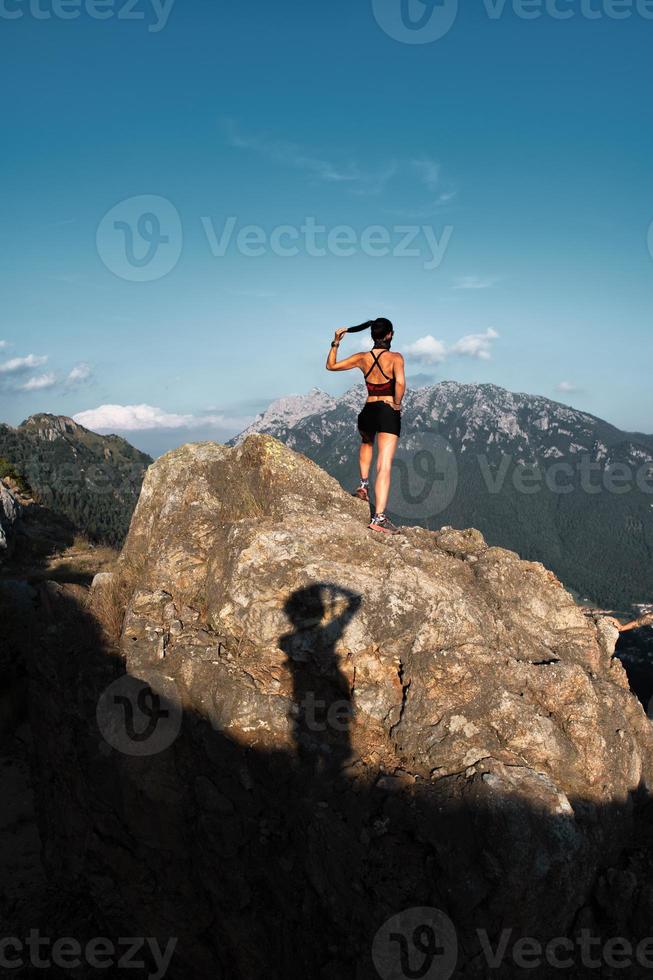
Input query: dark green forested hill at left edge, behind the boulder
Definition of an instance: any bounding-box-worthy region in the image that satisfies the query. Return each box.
[0,414,152,545]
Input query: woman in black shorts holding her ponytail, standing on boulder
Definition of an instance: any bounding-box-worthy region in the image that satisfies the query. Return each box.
[326,317,406,534]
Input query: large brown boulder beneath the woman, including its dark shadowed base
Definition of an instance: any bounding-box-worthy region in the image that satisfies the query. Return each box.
[24,436,653,980]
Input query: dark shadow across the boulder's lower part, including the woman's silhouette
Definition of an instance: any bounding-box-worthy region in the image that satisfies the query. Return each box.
[10,582,653,980]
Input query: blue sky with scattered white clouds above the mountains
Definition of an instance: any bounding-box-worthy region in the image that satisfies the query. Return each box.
[0,0,653,451]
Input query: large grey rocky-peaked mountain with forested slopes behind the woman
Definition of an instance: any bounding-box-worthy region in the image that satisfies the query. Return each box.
[231,381,653,607]
